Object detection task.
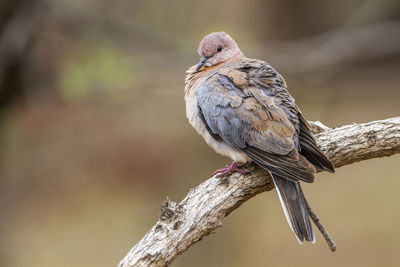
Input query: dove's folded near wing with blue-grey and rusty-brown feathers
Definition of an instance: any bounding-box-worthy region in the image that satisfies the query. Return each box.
[197,61,315,182]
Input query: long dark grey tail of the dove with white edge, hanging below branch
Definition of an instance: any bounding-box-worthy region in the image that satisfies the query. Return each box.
[271,174,315,244]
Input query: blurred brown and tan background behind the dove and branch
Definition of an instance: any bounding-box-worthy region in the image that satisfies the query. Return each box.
[0,0,400,267]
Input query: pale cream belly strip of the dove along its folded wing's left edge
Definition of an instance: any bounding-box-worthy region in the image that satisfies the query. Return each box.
[185,92,250,163]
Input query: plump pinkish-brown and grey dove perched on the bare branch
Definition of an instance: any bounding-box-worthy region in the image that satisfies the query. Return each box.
[184,32,335,244]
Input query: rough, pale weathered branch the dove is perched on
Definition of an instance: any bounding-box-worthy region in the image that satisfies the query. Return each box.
[118,117,400,267]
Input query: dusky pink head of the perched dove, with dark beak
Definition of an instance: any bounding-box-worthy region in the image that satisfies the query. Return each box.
[196,32,243,71]
